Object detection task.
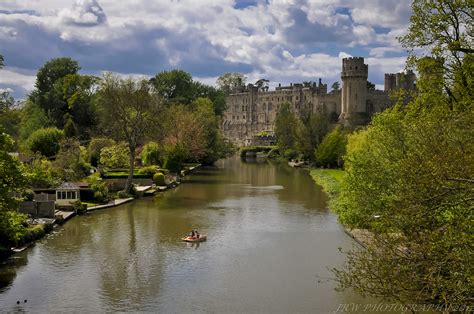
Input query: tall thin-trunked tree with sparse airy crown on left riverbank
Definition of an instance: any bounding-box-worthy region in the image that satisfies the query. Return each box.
[98,74,161,193]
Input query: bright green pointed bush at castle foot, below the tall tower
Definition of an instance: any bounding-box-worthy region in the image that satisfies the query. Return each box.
[314,126,347,167]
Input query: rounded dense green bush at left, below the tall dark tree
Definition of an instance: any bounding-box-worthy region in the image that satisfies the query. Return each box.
[28,128,64,157]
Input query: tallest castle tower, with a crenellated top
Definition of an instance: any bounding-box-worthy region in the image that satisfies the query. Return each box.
[339,57,369,126]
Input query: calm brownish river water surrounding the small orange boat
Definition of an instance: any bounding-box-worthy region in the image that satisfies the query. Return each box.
[0,158,370,313]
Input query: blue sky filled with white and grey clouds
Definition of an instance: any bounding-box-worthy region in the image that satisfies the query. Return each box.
[0,0,411,99]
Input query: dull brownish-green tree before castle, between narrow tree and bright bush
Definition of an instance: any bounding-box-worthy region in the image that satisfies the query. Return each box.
[295,111,329,160]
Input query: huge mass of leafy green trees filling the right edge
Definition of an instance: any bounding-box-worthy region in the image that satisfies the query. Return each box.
[331,0,474,311]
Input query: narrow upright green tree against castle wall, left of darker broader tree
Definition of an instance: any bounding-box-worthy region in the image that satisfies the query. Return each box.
[275,103,297,152]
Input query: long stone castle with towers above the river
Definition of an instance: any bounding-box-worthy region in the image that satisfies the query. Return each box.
[222,57,415,146]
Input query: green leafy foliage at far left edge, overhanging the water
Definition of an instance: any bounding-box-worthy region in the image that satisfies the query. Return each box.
[0,126,27,254]
